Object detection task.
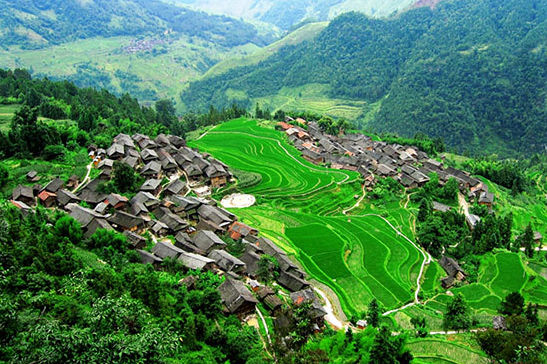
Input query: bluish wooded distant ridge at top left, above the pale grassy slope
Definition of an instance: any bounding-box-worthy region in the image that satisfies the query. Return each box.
[0,0,272,48]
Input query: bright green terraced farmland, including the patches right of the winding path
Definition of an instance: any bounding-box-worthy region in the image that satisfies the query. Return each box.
[189,119,547,320]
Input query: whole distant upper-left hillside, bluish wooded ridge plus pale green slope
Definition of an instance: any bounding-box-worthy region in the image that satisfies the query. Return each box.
[0,0,274,107]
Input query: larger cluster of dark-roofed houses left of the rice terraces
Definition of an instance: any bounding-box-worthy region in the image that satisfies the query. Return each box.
[8,134,326,329]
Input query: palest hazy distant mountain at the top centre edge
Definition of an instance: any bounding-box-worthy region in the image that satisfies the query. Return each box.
[173,0,414,29]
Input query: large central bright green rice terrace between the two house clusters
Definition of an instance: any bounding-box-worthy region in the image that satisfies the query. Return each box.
[190,120,423,312]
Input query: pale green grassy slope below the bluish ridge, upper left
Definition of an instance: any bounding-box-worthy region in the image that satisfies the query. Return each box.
[0,36,259,107]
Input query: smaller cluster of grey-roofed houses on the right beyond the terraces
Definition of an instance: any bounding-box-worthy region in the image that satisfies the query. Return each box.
[278,119,494,202]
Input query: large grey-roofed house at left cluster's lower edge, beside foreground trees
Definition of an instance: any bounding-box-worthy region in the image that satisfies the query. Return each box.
[218,277,258,318]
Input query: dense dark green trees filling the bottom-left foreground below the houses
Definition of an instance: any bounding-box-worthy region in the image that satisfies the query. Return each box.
[0,207,263,363]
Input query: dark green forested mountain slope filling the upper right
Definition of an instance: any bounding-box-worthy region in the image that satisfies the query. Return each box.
[182,0,547,155]
